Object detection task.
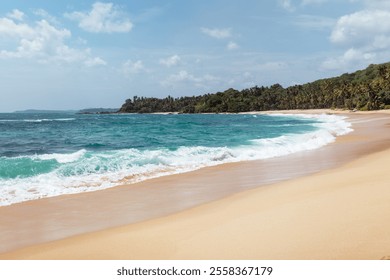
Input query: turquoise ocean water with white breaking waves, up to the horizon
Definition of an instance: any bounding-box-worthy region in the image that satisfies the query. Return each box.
[0,113,352,206]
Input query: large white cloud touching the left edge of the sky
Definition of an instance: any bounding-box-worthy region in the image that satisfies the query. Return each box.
[0,13,105,66]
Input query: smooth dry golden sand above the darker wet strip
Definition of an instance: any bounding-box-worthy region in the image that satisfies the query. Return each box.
[0,143,390,260]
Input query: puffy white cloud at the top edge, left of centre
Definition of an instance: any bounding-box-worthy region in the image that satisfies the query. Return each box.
[65,2,133,33]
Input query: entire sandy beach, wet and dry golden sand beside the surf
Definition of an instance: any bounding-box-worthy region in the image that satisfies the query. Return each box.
[0,110,390,260]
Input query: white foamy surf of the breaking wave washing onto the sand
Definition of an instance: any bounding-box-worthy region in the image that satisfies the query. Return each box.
[0,115,352,205]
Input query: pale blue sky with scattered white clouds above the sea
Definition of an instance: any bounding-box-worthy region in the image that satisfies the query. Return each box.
[0,0,390,112]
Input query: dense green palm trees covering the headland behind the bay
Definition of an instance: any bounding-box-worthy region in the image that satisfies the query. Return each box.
[119,63,390,113]
